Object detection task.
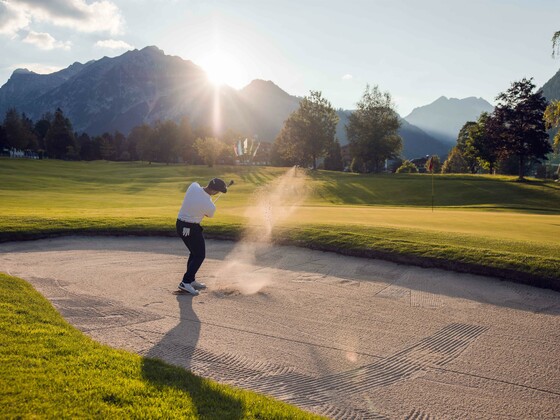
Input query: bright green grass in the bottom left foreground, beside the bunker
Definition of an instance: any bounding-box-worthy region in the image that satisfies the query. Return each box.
[0,274,319,419]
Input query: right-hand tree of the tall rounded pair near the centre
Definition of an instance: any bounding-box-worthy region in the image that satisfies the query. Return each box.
[346,85,402,172]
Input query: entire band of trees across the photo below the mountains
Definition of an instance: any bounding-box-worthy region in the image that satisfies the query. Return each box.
[0,79,560,179]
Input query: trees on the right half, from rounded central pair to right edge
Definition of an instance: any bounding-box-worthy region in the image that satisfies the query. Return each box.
[274,78,560,179]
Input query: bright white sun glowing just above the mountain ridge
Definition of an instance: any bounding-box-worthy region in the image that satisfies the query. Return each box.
[200,51,248,88]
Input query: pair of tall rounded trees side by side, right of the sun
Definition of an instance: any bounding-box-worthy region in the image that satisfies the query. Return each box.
[274,85,402,172]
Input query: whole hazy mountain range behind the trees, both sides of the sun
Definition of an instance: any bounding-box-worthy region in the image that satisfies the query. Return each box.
[0,46,504,158]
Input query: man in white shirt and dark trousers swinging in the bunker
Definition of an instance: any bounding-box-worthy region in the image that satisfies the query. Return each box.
[176,178,227,296]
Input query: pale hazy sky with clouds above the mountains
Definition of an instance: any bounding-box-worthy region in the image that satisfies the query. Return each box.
[0,0,560,116]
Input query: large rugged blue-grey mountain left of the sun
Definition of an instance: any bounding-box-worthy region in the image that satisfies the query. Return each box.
[0,47,212,134]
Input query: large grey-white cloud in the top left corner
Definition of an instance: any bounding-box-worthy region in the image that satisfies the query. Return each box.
[0,0,124,34]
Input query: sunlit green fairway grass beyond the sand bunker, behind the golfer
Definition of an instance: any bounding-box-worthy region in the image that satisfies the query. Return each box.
[0,159,560,287]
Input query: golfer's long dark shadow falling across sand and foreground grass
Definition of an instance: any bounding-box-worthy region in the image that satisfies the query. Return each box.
[142,295,243,419]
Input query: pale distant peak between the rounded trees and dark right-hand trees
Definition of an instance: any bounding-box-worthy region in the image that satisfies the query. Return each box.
[404,96,494,144]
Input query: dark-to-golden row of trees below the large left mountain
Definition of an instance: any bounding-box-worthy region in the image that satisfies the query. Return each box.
[0,108,268,166]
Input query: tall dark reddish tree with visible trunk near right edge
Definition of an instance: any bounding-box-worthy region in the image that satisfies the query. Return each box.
[493,78,552,180]
